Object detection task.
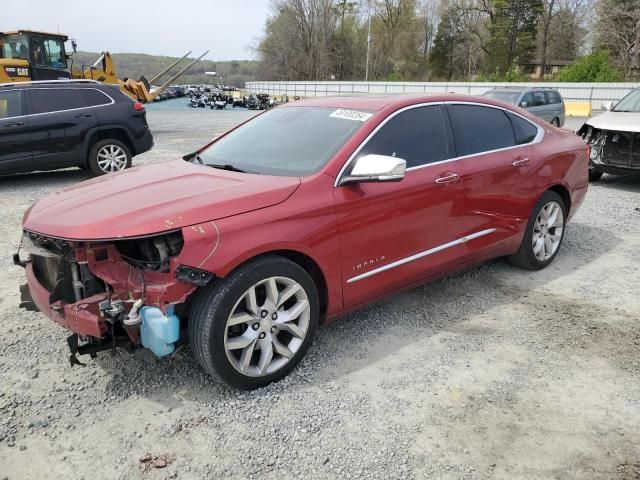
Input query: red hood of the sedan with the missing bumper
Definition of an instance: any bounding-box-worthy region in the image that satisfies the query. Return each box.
[23,160,300,240]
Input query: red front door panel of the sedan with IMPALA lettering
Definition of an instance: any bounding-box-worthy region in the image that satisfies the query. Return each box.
[334,164,464,308]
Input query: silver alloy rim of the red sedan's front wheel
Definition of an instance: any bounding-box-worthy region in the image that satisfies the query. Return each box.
[224,277,311,377]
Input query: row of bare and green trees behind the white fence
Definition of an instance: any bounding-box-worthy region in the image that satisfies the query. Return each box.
[256,0,640,81]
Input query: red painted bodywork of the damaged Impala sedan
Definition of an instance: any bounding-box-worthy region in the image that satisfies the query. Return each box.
[23,95,588,337]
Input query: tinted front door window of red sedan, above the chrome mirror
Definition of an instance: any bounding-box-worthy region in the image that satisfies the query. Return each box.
[354,105,450,168]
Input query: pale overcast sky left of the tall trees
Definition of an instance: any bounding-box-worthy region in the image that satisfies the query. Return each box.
[0,0,270,60]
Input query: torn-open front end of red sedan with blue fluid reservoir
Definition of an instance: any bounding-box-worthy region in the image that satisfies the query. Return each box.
[14,230,213,365]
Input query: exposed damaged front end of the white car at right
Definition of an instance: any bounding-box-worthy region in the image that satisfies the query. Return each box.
[577,124,640,175]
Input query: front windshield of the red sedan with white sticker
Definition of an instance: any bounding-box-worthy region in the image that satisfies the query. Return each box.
[200,107,373,177]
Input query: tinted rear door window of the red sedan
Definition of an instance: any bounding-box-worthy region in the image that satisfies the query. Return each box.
[447,104,516,157]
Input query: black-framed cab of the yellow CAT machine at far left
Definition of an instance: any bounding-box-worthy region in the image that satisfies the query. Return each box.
[0,30,71,83]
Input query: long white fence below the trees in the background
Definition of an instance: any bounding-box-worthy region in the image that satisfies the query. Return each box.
[245,82,640,110]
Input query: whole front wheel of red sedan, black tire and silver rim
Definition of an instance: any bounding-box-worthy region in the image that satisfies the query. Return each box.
[188,255,319,390]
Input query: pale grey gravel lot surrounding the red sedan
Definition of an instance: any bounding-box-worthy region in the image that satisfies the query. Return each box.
[0,101,640,480]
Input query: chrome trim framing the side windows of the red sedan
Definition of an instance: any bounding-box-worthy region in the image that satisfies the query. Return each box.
[333,100,544,187]
